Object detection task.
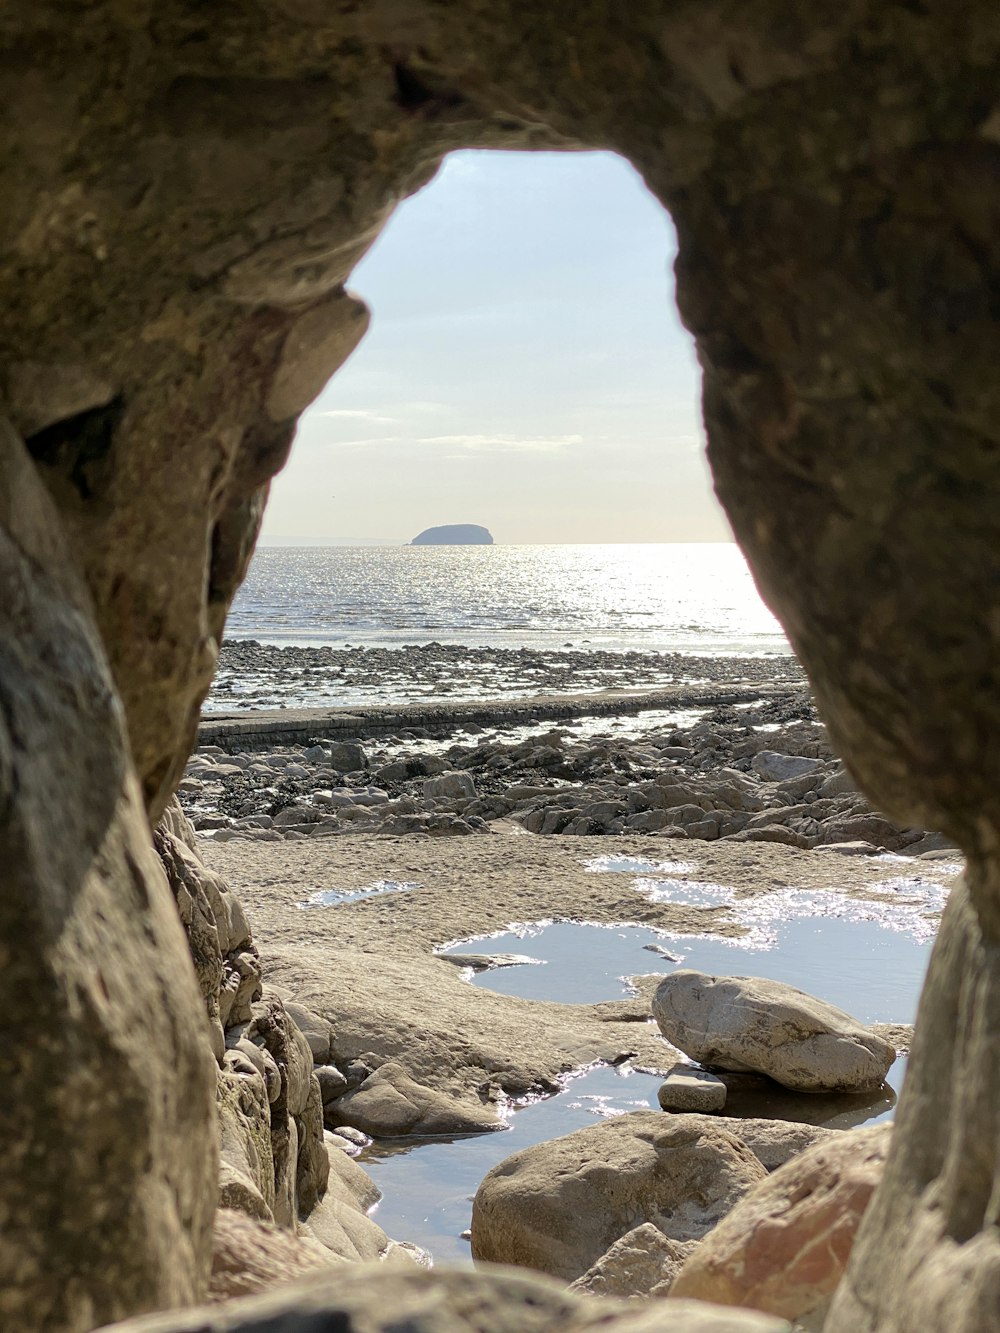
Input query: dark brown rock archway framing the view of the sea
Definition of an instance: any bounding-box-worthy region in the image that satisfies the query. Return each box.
[0,0,1000,1333]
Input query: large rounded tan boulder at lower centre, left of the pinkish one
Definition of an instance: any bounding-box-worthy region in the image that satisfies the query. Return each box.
[472,1112,767,1281]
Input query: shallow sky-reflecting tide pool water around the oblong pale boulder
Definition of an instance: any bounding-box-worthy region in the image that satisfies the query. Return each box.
[361,890,945,1264]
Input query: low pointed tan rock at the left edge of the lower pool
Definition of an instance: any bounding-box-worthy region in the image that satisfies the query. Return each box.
[328,1061,500,1137]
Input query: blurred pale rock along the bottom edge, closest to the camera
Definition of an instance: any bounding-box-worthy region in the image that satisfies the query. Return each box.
[101,1264,791,1333]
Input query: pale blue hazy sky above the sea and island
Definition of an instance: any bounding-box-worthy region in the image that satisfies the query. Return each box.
[263,151,731,545]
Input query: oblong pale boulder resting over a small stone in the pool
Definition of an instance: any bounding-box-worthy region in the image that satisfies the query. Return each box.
[652,968,896,1092]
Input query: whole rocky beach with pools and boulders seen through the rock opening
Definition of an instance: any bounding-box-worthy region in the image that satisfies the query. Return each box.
[148,643,961,1328]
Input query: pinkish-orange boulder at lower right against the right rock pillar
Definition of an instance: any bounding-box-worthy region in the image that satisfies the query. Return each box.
[671,1125,892,1325]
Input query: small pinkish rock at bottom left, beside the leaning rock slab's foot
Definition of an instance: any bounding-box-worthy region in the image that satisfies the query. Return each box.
[208,1208,337,1301]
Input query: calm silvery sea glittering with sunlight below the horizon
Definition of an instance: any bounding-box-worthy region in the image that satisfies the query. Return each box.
[227,543,791,656]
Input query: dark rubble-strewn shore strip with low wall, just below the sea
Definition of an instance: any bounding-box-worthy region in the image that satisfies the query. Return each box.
[189,643,948,856]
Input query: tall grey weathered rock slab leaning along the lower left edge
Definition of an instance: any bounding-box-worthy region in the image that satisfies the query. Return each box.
[0,427,216,1333]
